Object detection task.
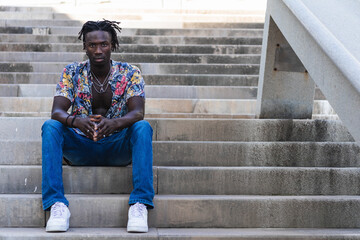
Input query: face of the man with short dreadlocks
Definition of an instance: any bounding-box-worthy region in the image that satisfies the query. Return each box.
[84,31,111,67]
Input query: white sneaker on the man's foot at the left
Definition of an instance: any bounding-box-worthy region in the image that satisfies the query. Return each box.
[46,202,71,232]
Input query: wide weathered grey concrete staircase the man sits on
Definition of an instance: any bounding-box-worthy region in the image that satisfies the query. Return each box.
[0,2,360,239]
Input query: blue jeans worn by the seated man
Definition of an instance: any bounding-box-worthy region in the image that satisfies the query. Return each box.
[42,119,154,210]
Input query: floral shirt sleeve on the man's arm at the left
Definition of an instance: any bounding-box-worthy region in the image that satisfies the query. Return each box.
[55,65,74,102]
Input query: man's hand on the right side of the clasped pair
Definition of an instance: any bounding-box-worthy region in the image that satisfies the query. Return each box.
[89,115,119,142]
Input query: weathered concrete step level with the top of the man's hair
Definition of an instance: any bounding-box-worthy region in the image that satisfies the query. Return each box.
[0,25,263,38]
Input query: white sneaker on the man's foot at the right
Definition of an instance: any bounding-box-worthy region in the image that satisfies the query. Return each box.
[127,202,148,233]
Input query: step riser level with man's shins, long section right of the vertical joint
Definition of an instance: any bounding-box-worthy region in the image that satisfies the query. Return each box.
[158,167,360,196]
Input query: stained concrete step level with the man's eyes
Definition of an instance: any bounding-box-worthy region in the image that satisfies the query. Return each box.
[0,43,261,54]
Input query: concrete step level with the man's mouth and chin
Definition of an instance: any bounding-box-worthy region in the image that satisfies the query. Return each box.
[0,52,260,64]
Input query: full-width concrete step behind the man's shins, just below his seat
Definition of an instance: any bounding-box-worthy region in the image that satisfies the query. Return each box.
[0,165,360,196]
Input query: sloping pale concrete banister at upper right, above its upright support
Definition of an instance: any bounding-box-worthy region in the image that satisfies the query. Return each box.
[258,0,360,142]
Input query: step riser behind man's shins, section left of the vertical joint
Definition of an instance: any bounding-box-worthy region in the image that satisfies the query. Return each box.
[0,165,158,194]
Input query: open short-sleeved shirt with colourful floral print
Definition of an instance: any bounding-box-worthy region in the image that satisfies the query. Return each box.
[55,60,145,135]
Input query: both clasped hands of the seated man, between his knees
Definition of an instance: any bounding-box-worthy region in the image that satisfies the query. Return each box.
[76,115,117,142]
